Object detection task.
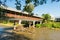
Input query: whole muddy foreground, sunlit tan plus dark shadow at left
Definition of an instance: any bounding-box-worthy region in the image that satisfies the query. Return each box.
[0,27,60,40]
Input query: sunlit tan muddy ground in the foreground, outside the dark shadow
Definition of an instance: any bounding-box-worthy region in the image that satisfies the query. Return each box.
[14,27,60,40]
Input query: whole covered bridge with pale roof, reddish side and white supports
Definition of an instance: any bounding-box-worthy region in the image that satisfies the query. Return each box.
[0,5,43,26]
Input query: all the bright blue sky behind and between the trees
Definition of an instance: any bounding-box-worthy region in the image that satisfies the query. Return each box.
[0,0,60,17]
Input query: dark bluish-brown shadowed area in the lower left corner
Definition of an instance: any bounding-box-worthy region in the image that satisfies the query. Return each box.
[0,27,30,40]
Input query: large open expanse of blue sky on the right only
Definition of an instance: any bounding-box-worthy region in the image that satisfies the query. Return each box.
[33,2,60,17]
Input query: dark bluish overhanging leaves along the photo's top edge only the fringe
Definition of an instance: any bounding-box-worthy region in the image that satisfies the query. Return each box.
[0,0,60,7]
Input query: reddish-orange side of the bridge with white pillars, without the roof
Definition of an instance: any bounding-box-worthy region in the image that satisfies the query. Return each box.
[6,13,42,26]
